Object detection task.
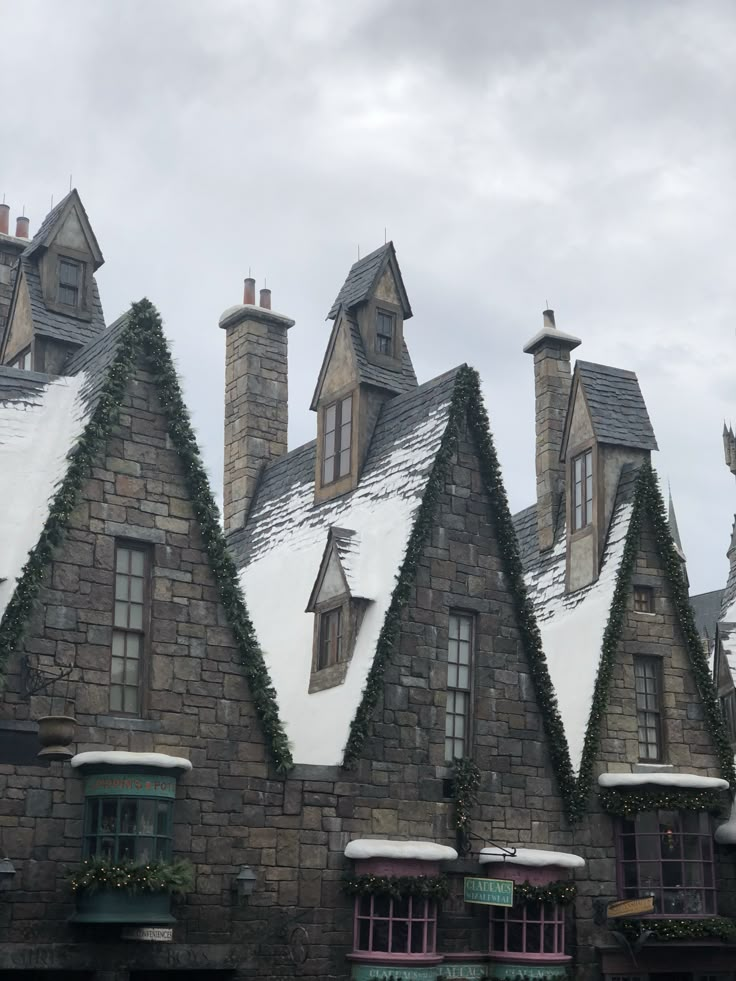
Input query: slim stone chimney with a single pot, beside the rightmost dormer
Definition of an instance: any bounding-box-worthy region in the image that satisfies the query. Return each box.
[524,310,580,551]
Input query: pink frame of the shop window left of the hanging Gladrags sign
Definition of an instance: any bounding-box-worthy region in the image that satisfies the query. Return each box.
[353,894,437,961]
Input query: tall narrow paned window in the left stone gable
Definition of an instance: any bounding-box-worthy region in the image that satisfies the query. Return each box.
[110,545,148,715]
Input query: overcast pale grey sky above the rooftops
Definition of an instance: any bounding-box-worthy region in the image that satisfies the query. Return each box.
[0,0,736,591]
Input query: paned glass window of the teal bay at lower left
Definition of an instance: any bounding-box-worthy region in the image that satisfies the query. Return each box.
[84,792,174,864]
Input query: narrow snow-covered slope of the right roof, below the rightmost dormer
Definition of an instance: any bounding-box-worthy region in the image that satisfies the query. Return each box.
[515,471,636,771]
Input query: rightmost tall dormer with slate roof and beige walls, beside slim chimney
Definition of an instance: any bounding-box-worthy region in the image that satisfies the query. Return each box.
[560,361,657,592]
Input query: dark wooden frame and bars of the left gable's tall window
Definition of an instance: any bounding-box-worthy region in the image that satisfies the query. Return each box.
[109,539,151,718]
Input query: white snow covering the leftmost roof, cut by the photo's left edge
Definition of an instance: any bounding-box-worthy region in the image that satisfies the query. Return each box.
[0,368,89,617]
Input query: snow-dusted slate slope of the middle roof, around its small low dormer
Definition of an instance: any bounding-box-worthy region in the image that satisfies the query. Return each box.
[231,371,456,765]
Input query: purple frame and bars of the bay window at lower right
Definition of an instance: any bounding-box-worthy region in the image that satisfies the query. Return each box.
[615,809,718,919]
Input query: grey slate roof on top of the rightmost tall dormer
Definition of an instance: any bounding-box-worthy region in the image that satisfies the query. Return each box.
[571,361,657,450]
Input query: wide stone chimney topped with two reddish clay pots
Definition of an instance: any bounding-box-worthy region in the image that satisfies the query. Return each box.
[220,277,294,535]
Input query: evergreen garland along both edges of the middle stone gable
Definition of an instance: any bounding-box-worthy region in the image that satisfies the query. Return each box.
[343,365,575,812]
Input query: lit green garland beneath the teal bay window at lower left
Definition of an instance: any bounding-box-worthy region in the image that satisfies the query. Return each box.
[69,858,194,896]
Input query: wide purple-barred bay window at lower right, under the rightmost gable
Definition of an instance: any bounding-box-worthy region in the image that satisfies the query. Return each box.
[617,811,716,916]
